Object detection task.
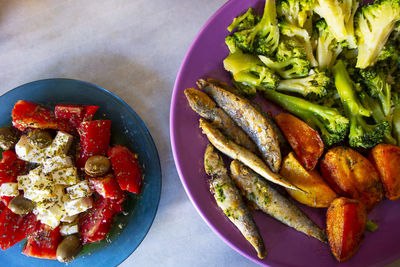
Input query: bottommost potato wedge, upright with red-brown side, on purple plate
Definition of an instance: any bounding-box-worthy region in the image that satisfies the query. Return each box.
[326,197,367,262]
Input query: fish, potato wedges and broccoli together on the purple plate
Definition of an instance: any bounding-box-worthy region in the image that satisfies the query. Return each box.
[185,0,400,262]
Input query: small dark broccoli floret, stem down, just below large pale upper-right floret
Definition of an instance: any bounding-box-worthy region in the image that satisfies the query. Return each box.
[360,66,392,117]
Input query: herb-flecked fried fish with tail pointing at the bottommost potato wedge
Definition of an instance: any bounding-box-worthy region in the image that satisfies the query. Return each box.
[230,160,326,243]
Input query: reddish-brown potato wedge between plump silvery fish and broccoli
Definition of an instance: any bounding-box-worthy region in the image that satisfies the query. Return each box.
[275,113,324,170]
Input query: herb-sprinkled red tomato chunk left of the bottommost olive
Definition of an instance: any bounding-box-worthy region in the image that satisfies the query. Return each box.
[22,224,62,260]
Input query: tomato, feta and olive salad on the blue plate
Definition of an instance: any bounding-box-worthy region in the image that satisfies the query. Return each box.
[0,101,142,262]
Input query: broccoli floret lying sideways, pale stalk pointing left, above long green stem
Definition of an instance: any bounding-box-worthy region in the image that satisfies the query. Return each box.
[276,72,330,97]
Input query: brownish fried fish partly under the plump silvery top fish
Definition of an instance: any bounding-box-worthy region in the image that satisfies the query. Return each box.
[184,88,257,153]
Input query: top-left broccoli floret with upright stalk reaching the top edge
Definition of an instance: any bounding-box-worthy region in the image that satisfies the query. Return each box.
[228,0,279,56]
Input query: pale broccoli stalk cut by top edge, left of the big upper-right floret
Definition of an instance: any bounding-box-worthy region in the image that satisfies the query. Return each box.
[314,0,360,48]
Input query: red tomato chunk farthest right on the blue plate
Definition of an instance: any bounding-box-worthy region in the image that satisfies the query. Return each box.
[108,146,142,194]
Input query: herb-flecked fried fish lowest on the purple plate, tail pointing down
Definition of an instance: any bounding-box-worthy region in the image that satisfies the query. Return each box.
[204,144,267,259]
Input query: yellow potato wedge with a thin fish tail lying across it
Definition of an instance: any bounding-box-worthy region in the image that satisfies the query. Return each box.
[280,152,338,208]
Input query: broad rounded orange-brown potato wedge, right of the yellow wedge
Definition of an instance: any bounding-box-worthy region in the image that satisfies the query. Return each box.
[320,147,383,212]
